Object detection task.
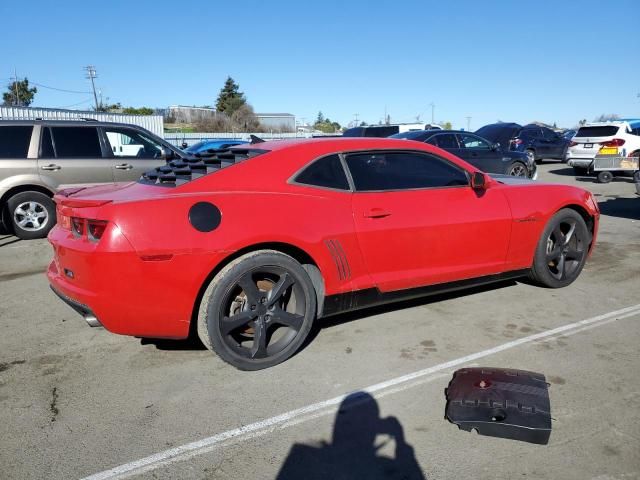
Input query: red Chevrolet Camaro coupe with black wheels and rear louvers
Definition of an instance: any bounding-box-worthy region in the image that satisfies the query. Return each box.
[48,138,599,370]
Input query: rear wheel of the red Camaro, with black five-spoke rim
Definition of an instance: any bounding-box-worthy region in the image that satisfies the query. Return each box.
[198,250,316,370]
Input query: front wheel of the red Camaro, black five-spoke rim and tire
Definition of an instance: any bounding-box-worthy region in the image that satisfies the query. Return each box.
[529,208,591,288]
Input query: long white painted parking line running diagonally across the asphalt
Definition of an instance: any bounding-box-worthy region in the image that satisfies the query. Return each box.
[83,304,640,480]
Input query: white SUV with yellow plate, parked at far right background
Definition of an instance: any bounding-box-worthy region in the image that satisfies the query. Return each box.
[565,119,640,175]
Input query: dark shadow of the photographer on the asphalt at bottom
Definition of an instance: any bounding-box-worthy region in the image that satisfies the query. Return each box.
[276,392,425,480]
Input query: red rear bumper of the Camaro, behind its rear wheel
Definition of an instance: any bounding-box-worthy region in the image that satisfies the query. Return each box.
[47,226,222,338]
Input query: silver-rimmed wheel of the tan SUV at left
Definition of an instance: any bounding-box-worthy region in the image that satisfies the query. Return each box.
[7,191,56,240]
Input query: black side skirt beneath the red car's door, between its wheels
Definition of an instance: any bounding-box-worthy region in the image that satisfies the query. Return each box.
[319,268,529,317]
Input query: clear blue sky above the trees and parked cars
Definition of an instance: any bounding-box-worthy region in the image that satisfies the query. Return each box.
[0,0,640,130]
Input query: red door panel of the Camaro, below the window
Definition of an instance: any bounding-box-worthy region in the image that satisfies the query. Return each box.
[352,187,512,291]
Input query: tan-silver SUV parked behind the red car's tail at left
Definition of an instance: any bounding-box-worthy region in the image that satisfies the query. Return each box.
[0,120,184,239]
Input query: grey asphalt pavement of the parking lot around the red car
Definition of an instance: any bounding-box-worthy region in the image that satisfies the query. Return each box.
[0,163,640,480]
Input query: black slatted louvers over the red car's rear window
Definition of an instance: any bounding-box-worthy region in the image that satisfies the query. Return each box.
[138,149,268,187]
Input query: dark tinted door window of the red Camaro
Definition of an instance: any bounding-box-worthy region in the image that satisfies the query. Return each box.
[347,152,469,192]
